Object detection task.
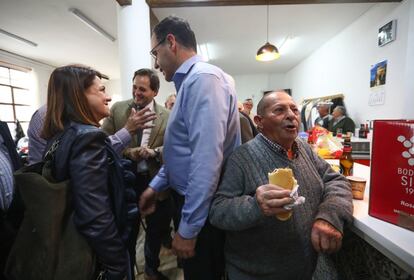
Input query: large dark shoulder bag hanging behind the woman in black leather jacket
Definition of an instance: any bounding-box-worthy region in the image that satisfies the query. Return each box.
[5,138,95,280]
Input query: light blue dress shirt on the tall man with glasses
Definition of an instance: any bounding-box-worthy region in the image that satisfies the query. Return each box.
[150,56,240,238]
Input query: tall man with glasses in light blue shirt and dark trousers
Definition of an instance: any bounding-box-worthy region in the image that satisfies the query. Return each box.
[140,16,240,279]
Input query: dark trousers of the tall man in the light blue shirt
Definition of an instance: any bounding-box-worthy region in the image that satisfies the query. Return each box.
[171,191,224,280]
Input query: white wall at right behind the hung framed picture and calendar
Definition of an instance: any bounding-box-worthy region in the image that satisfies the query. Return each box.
[286,0,414,124]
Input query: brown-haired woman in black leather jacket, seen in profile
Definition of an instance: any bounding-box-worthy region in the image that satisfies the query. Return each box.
[42,65,130,279]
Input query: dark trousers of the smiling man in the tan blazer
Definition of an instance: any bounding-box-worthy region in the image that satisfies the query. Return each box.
[144,197,173,275]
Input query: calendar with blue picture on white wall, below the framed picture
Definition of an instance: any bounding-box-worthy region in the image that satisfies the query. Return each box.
[368,60,387,106]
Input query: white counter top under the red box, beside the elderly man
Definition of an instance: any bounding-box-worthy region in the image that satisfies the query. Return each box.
[351,163,414,275]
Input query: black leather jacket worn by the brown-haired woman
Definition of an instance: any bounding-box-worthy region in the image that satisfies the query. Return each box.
[48,122,128,279]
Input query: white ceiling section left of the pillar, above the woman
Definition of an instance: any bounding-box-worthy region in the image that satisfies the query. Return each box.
[0,0,119,77]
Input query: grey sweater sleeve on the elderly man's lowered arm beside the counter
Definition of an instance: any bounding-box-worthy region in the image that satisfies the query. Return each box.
[306,143,353,232]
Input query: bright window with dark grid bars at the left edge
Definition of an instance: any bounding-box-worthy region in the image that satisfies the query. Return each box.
[0,65,33,135]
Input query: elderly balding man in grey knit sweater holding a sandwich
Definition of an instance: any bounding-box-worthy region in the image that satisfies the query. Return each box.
[210,92,352,280]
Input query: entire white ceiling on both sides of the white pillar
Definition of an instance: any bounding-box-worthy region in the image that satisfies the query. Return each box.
[0,0,375,78]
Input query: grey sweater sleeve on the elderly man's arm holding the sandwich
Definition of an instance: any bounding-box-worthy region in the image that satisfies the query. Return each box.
[210,154,263,231]
